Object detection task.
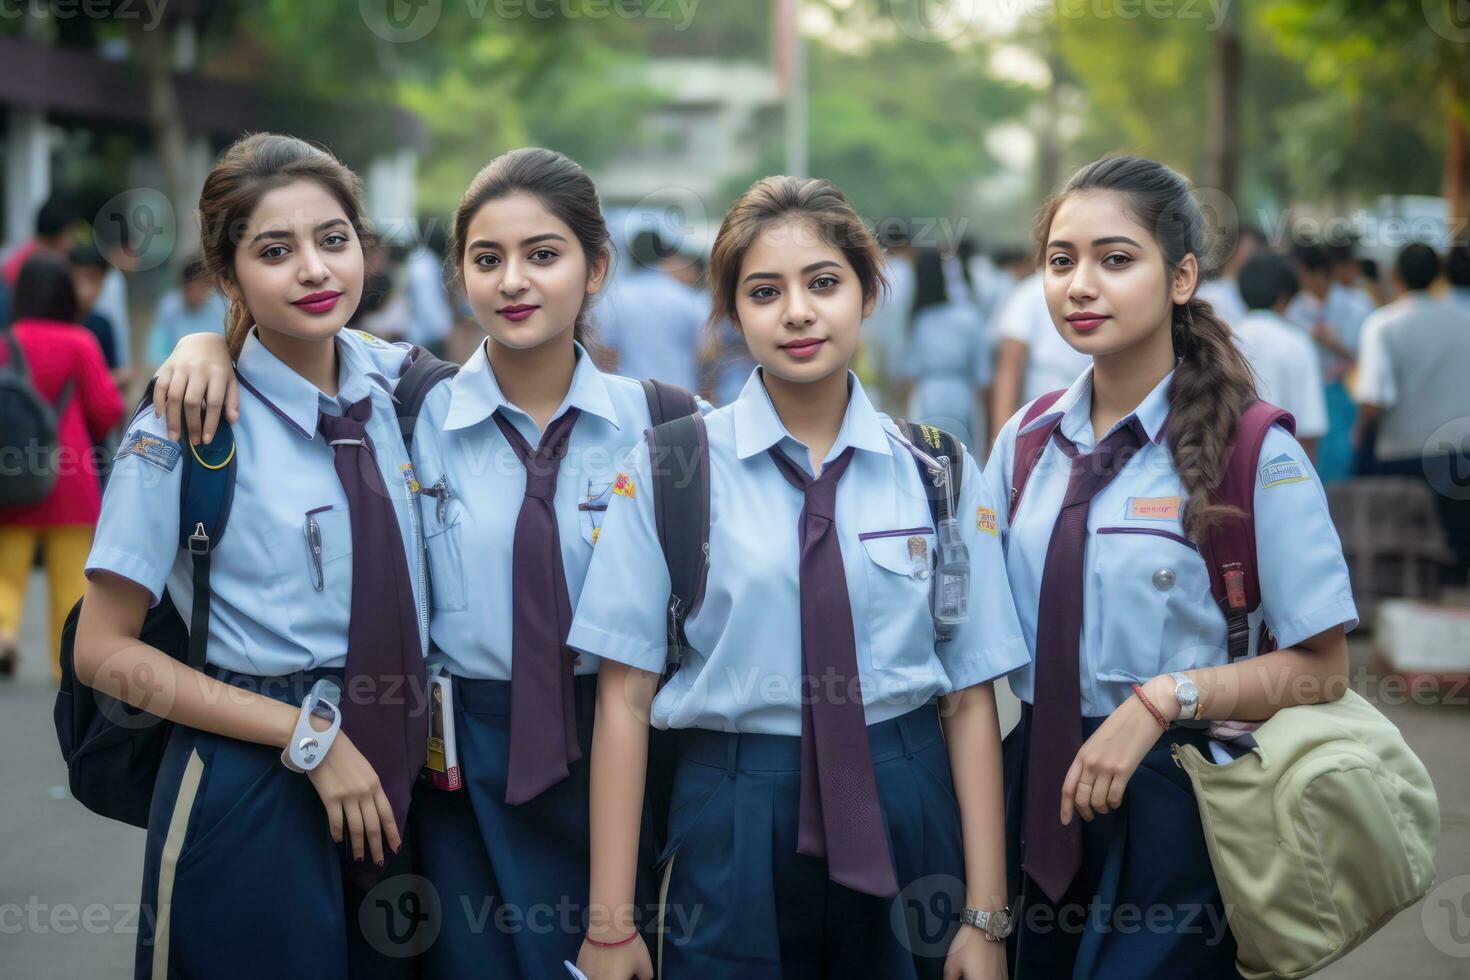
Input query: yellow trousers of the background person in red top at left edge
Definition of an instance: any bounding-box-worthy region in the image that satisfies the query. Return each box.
[0,525,93,680]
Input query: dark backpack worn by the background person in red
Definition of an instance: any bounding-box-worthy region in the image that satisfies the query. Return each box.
[0,328,72,507]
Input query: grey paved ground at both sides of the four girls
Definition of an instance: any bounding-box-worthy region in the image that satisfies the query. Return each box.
[0,570,1470,980]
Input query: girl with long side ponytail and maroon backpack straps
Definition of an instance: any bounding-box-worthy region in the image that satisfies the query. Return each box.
[985,157,1357,980]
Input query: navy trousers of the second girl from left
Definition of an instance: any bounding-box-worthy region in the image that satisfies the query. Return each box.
[415,674,653,980]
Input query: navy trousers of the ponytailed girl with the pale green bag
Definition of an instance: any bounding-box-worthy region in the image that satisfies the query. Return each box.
[1003,705,1239,980]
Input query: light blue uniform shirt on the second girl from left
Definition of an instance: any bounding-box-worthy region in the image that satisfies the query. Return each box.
[402,344,699,680]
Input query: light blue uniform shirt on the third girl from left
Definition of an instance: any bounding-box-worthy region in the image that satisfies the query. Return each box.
[567,369,1028,735]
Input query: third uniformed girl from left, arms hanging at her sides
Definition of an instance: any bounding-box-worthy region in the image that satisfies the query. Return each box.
[569,176,1026,980]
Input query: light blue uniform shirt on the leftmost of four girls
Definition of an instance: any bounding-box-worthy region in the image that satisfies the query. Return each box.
[87,331,428,676]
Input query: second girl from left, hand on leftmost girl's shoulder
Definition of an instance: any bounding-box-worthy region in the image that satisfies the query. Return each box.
[156,147,709,979]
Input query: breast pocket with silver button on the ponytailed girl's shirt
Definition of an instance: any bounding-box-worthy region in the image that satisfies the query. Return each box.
[1092,527,1225,683]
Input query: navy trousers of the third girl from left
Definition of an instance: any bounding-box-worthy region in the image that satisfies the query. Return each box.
[650,704,964,980]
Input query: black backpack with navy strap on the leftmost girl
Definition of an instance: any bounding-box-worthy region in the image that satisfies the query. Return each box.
[53,353,457,827]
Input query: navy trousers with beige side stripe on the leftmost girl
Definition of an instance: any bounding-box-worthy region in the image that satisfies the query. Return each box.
[135,669,372,980]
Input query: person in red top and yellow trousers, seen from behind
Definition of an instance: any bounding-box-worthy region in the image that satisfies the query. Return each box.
[0,256,123,679]
